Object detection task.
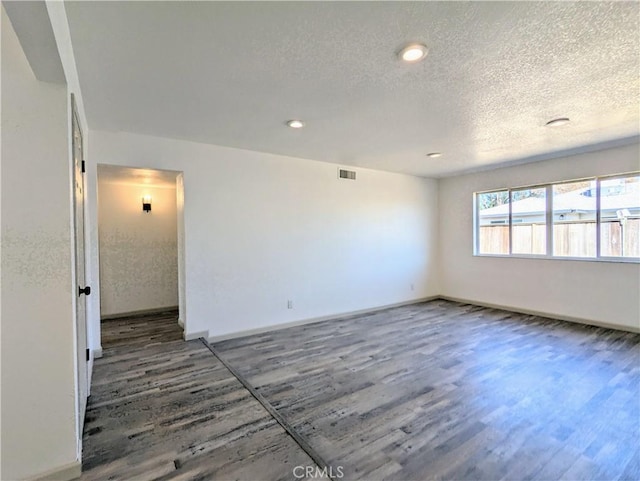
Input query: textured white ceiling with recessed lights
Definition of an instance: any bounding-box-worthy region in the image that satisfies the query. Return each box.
[65,2,640,177]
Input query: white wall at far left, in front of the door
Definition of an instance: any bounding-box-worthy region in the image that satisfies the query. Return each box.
[1,9,77,480]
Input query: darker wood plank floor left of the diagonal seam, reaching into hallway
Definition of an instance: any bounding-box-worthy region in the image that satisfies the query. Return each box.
[81,313,324,480]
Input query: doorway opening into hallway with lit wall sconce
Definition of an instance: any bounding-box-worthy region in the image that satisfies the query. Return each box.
[97,164,186,347]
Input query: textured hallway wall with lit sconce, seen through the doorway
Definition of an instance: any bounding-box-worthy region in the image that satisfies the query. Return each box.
[98,176,178,316]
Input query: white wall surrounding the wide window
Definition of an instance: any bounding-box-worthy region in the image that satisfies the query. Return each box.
[439,144,640,329]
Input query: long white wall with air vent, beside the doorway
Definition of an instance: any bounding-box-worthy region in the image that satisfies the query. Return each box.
[89,127,439,336]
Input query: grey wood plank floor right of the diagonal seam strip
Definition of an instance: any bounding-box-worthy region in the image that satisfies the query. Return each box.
[215,301,640,480]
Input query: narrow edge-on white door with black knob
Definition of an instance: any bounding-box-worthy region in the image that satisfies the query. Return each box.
[71,95,91,437]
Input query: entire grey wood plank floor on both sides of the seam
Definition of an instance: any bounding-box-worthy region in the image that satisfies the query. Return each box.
[82,301,640,481]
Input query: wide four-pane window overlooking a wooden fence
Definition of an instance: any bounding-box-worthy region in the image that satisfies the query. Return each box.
[474,173,640,261]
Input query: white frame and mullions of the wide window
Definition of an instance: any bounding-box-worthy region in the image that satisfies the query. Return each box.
[473,171,640,264]
